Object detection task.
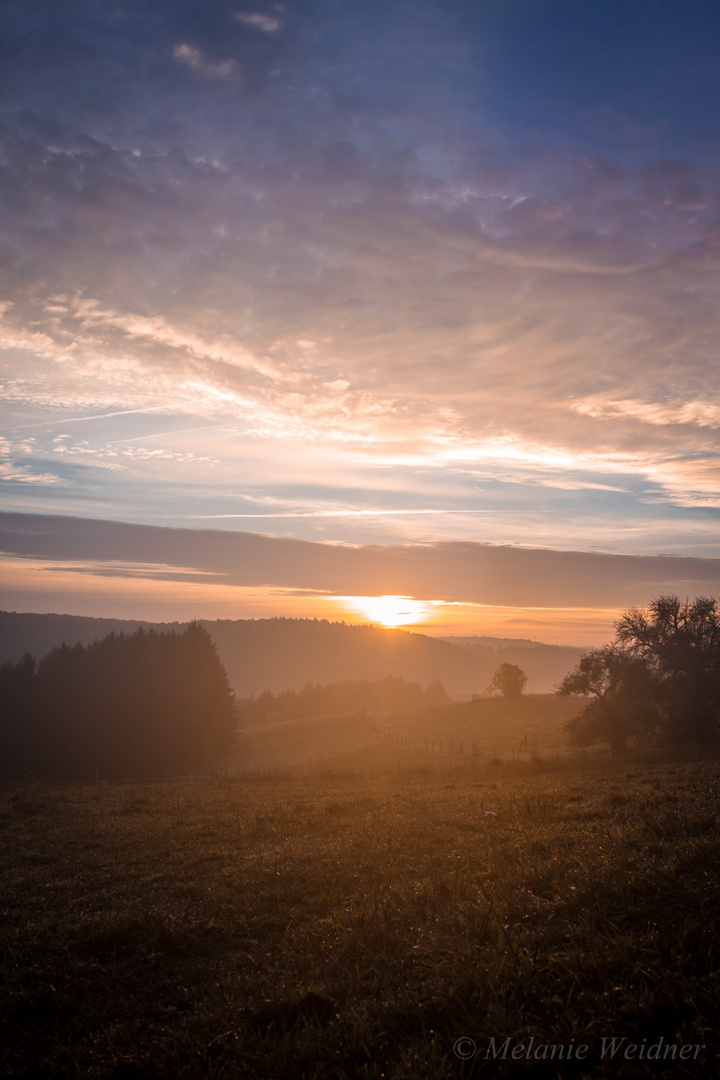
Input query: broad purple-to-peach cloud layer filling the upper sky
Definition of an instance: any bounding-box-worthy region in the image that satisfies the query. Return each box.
[0,0,720,550]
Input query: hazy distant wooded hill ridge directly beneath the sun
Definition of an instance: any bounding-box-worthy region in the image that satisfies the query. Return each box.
[0,611,581,698]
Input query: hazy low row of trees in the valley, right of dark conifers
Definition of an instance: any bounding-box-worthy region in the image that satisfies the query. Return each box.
[237,675,448,726]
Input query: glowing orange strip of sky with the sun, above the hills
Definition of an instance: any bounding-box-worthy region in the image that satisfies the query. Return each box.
[0,557,622,646]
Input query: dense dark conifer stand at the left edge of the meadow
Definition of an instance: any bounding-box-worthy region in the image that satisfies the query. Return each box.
[0,622,236,780]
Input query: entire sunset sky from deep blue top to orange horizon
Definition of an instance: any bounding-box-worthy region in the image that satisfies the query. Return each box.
[0,0,720,644]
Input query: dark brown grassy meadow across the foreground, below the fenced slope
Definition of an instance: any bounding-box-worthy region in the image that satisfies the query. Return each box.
[0,754,720,1080]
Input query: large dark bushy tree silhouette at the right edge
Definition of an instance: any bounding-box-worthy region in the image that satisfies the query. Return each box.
[557,596,720,748]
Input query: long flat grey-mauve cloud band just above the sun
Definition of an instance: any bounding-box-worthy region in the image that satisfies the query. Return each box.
[0,514,720,608]
